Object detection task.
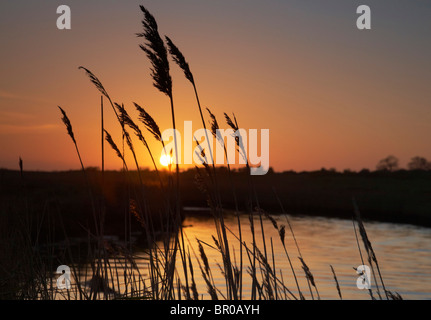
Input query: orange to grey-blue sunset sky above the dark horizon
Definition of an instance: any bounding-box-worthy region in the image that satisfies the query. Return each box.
[0,0,431,171]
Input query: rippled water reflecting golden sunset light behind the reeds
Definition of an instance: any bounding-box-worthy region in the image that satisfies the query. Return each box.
[64,214,431,300]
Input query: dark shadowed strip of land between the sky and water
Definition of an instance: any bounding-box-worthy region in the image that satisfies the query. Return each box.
[0,168,431,238]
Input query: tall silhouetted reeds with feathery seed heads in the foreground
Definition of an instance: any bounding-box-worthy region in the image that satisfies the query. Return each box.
[0,6,400,300]
